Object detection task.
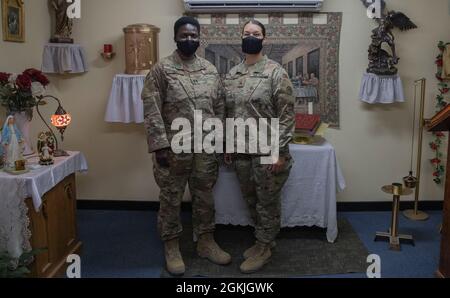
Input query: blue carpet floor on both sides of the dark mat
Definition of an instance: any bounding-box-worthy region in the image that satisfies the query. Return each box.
[78,210,442,278]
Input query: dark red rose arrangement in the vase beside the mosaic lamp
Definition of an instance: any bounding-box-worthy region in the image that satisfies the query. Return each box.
[0,68,50,112]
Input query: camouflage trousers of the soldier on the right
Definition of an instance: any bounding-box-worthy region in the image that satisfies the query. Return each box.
[233,153,293,243]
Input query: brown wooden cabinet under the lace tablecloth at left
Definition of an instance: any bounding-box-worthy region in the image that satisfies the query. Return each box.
[26,174,81,277]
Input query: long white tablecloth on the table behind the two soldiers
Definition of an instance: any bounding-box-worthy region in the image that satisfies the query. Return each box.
[214,142,345,242]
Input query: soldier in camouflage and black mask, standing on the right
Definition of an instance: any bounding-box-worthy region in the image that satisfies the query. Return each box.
[224,21,295,273]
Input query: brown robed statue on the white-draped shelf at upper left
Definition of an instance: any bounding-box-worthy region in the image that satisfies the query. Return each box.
[49,0,73,43]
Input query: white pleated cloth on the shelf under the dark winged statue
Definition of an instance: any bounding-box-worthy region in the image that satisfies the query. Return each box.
[359,73,405,104]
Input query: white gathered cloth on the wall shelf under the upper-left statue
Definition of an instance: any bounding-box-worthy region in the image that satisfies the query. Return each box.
[42,43,88,74]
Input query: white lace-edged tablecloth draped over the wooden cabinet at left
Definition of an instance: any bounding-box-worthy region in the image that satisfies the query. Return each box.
[0,152,87,258]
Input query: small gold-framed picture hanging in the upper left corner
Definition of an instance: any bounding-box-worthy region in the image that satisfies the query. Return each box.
[1,0,25,42]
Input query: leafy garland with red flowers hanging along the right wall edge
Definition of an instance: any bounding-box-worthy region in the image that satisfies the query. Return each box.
[430,41,450,184]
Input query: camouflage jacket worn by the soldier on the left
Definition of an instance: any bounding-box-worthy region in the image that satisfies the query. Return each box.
[142,51,225,153]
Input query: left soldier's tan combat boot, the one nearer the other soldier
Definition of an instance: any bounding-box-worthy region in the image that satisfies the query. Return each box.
[197,233,231,265]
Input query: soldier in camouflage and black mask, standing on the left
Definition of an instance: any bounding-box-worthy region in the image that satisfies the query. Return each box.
[142,17,231,275]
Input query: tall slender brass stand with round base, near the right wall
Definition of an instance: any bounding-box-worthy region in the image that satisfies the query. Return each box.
[403,78,429,220]
